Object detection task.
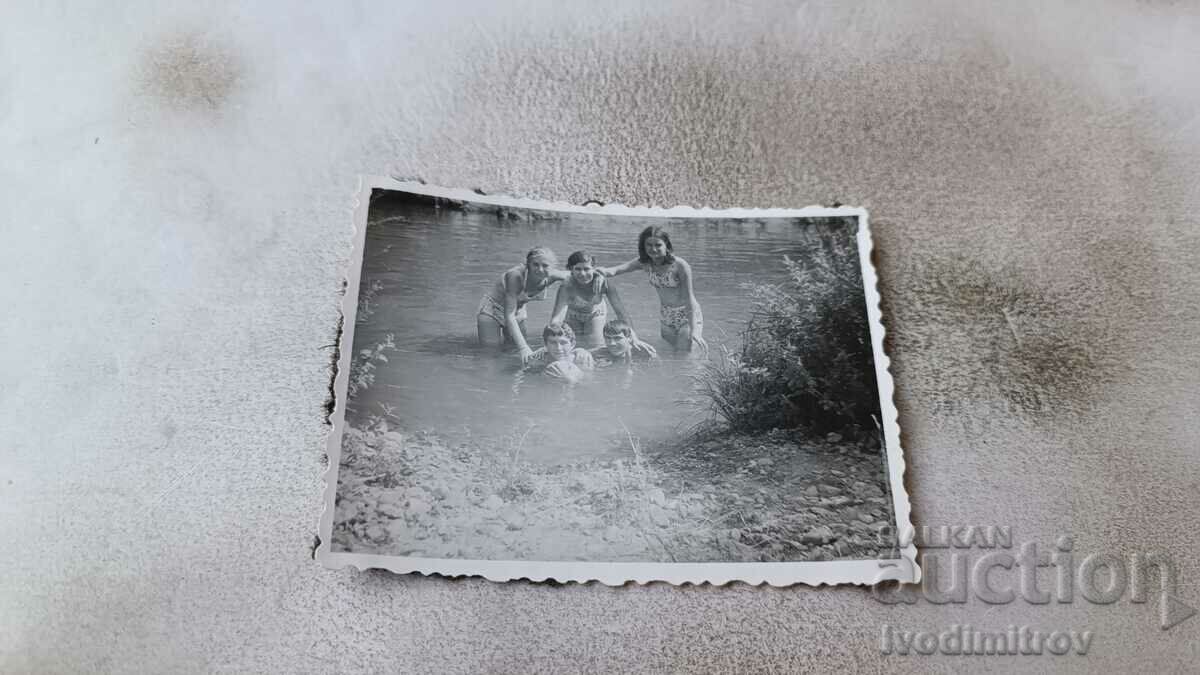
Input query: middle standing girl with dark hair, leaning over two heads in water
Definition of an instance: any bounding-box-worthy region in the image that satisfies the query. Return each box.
[550,251,648,347]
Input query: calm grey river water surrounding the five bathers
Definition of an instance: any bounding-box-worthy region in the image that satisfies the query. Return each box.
[349,196,854,464]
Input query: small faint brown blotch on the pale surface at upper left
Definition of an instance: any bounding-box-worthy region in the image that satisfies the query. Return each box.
[139,32,246,113]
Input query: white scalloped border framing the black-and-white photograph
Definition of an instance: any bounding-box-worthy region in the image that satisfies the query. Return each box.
[316,177,922,586]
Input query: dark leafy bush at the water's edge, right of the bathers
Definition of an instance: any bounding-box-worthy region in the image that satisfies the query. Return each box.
[698,228,880,438]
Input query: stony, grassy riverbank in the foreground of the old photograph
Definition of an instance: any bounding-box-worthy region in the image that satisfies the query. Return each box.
[332,428,894,562]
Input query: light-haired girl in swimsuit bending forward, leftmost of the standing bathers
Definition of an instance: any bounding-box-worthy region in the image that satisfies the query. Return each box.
[475,246,568,364]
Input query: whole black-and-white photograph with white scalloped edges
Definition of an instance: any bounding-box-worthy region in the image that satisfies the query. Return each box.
[319,180,919,584]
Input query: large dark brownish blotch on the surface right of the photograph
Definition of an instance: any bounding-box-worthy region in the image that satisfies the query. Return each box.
[884,252,1127,420]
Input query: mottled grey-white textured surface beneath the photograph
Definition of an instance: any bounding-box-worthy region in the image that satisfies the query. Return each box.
[0,1,1200,671]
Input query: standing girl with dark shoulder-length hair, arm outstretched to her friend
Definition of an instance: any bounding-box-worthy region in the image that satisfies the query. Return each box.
[600,226,708,354]
